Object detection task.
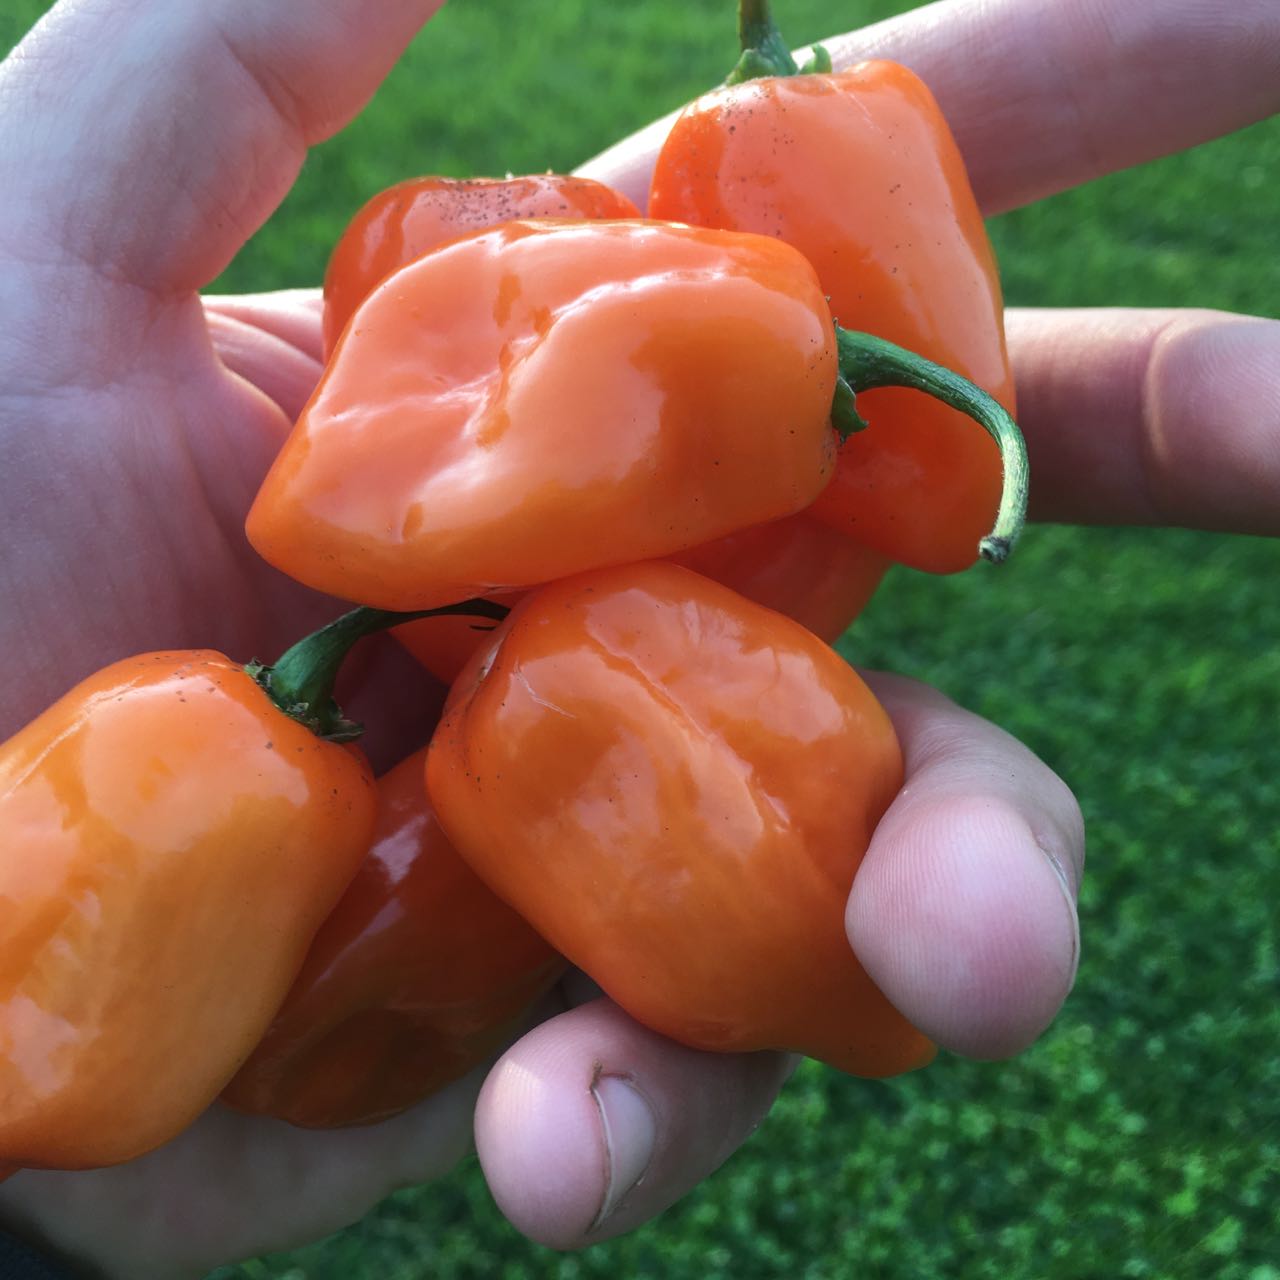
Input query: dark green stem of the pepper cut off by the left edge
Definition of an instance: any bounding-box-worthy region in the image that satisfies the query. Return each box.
[244,599,511,742]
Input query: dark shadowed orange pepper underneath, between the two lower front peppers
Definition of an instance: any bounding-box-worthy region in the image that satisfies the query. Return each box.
[223,749,564,1128]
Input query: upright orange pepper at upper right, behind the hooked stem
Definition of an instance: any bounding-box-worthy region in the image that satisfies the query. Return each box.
[648,61,1014,572]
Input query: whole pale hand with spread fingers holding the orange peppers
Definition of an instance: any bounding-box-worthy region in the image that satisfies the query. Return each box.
[0,0,1280,1277]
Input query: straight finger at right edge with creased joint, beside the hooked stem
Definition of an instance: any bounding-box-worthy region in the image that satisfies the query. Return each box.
[1006,310,1280,534]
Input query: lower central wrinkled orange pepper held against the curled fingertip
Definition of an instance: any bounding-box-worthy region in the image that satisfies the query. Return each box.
[428,563,932,1075]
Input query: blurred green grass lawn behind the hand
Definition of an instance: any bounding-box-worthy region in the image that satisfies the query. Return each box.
[0,0,1280,1280]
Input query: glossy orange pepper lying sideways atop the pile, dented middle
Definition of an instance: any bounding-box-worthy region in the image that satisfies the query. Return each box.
[247,221,837,609]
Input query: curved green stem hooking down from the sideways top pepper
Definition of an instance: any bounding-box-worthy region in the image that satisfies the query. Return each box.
[831,325,1028,564]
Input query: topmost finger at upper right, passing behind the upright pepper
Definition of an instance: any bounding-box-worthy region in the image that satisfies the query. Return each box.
[579,0,1280,212]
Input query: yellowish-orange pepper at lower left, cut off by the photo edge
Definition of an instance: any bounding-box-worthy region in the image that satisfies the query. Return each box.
[0,650,375,1169]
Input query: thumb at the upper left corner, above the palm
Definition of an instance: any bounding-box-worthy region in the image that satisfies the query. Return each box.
[0,0,442,297]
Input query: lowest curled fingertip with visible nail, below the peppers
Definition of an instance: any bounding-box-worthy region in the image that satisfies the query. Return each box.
[475,1000,791,1249]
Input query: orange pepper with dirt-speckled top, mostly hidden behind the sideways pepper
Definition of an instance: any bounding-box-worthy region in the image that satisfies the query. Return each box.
[324,173,640,360]
